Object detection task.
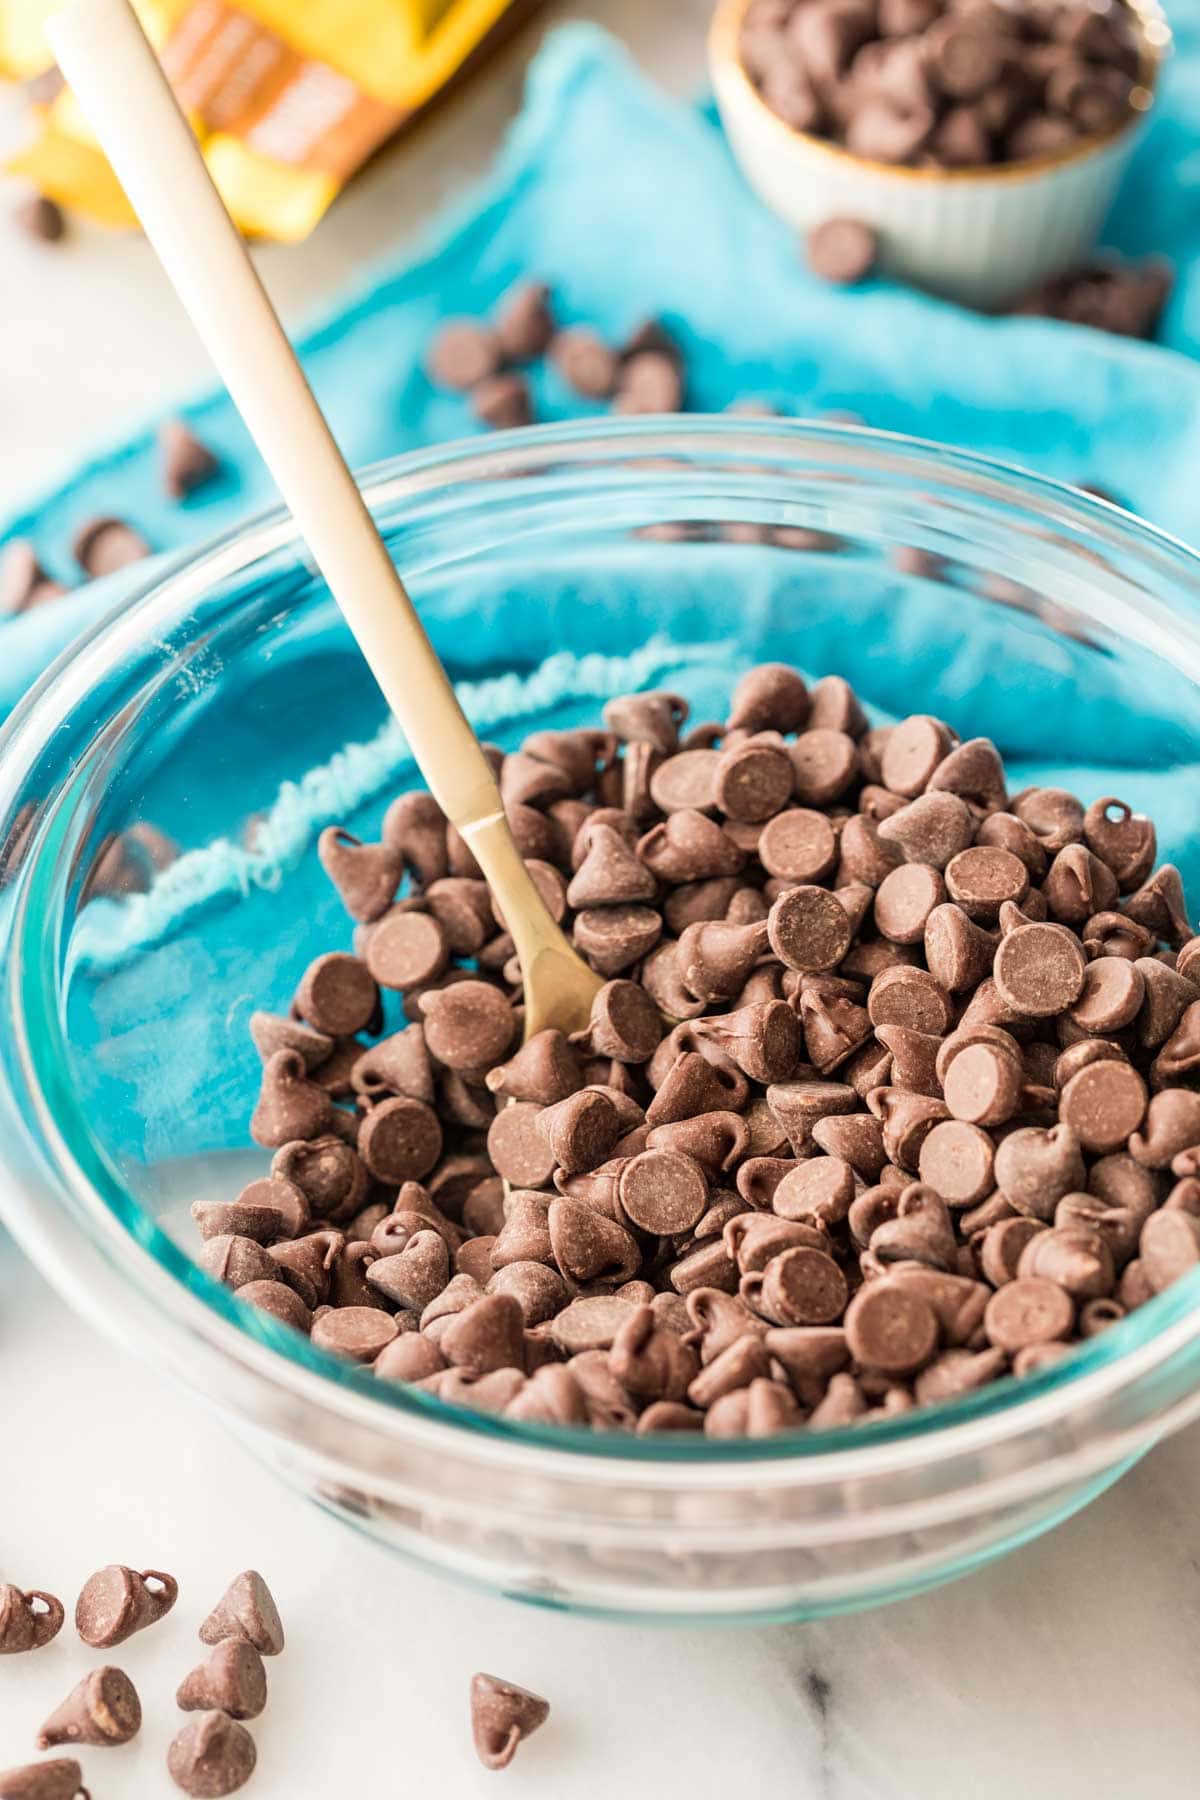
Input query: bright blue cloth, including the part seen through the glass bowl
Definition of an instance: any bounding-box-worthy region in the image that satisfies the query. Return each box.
[0,16,1200,1159]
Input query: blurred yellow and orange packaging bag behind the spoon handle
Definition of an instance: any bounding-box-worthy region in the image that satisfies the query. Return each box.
[0,0,525,243]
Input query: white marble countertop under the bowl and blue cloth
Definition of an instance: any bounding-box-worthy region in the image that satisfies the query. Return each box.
[0,0,1200,1800]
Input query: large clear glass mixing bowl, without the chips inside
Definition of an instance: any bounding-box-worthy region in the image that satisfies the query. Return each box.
[0,416,1200,1620]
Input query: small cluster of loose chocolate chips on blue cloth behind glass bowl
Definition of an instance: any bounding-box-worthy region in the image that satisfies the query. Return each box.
[428,281,684,428]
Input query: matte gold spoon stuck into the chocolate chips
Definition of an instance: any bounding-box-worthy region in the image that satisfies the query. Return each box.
[47,0,603,1039]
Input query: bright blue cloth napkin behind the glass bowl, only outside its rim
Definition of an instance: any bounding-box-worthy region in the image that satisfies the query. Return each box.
[0,21,1200,716]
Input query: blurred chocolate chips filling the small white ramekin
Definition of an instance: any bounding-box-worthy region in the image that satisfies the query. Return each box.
[741,0,1141,169]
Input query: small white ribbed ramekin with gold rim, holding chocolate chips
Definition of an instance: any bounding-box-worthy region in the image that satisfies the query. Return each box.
[709,0,1171,308]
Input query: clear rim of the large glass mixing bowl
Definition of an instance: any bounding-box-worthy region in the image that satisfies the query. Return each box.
[0,414,1200,1485]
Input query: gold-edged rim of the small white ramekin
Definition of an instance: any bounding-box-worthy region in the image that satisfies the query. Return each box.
[709,0,1173,187]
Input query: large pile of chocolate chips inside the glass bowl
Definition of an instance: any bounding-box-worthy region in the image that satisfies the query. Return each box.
[194,664,1200,1436]
